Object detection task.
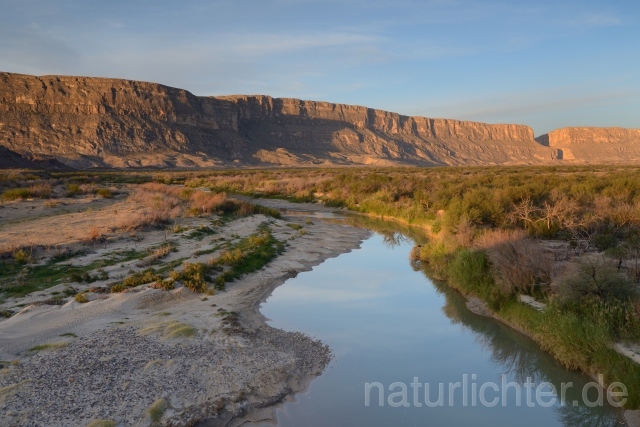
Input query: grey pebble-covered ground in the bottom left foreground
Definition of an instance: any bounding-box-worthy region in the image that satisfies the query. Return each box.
[0,326,329,427]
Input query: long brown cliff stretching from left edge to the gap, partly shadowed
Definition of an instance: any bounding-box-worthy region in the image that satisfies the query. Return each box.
[0,73,554,167]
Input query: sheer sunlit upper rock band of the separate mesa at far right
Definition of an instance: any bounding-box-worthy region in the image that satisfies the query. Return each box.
[536,127,640,147]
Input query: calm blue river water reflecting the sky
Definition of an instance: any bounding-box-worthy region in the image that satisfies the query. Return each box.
[254,235,617,427]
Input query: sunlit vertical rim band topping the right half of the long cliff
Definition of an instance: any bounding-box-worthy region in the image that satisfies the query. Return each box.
[215,95,533,142]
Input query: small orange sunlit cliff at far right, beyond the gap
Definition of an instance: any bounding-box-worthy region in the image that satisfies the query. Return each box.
[536,127,640,163]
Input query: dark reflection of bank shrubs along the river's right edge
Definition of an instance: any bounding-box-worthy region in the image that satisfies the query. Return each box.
[424,281,619,427]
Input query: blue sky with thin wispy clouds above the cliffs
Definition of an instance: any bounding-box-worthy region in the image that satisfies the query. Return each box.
[0,0,640,135]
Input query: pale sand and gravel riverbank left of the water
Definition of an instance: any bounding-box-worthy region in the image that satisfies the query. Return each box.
[0,197,368,427]
